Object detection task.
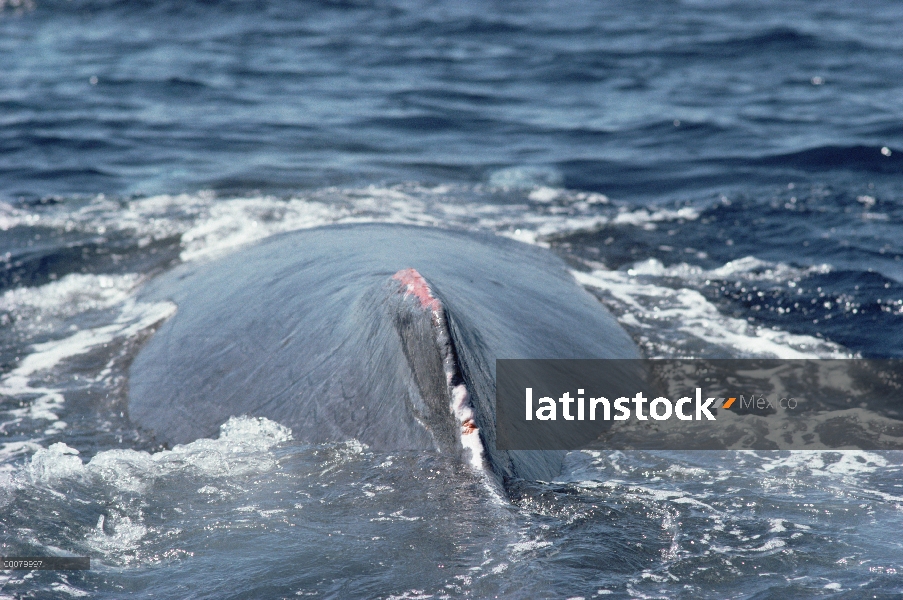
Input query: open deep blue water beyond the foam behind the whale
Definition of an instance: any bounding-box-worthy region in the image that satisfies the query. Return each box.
[0,0,903,202]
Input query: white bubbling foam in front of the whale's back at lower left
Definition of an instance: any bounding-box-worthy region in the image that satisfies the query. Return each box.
[9,416,296,564]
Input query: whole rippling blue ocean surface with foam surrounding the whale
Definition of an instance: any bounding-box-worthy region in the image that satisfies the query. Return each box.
[0,0,903,600]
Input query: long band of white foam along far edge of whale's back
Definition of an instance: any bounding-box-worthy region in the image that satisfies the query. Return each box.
[0,186,698,261]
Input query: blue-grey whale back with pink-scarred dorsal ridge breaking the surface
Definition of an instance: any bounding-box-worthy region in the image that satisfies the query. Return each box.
[128,223,640,485]
